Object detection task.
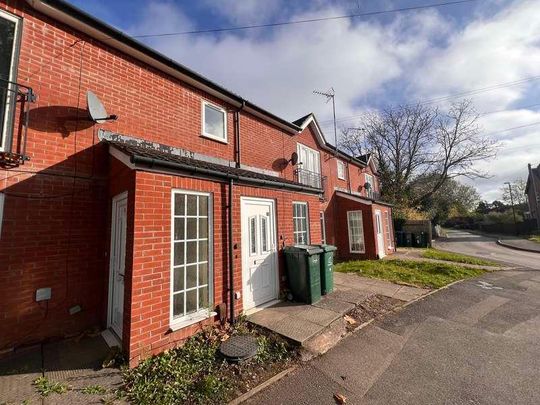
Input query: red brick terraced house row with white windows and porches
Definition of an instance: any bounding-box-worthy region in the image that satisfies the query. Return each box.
[0,0,394,365]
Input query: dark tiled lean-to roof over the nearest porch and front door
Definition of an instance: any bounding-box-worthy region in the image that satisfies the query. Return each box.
[104,140,322,194]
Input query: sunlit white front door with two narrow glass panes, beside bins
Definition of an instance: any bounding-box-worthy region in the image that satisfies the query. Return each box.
[241,197,278,311]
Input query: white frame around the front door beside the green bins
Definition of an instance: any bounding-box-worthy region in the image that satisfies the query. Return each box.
[240,197,279,312]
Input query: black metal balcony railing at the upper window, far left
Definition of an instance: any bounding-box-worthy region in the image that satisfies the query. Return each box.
[0,78,36,167]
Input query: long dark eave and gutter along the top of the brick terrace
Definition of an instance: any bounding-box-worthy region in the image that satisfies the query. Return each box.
[34,0,300,131]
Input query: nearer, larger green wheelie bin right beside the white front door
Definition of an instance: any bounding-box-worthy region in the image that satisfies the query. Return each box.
[283,245,323,304]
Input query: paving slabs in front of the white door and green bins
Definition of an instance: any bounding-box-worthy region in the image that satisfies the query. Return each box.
[248,273,430,353]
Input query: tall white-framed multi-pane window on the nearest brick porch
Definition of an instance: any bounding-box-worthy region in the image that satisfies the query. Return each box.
[171,190,212,323]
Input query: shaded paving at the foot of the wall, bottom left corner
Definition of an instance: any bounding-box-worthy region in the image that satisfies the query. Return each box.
[0,335,122,405]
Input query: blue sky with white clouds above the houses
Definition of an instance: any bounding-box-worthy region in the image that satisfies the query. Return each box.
[70,0,540,201]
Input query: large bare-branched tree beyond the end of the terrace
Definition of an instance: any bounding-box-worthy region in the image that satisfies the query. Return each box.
[341,100,497,206]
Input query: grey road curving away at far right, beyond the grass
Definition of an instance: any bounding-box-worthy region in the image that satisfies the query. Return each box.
[436,230,540,270]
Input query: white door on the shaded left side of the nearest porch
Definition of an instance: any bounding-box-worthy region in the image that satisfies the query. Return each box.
[107,192,127,339]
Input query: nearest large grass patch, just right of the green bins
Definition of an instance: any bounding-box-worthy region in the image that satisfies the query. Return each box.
[334,260,486,288]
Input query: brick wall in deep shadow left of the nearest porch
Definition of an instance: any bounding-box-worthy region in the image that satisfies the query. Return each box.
[0,144,109,349]
